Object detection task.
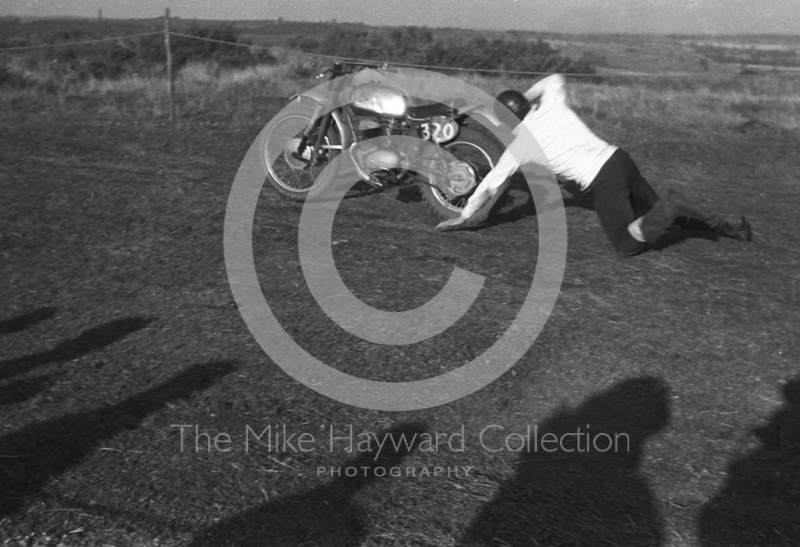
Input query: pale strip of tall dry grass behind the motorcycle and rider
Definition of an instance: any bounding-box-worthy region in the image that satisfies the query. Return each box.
[0,62,800,133]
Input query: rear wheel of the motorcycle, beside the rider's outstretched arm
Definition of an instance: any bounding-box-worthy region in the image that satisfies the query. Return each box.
[419,126,503,221]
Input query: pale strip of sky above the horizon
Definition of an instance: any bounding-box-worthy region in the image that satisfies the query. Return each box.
[0,0,800,34]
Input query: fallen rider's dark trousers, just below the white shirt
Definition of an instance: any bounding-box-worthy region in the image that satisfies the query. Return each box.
[589,149,659,256]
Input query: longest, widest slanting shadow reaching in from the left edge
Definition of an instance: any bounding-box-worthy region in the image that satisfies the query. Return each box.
[0,362,234,520]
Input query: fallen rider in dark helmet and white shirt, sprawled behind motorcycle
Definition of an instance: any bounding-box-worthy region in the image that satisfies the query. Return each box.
[436,74,752,256]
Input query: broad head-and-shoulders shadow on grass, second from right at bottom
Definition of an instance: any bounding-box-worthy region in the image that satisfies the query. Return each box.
[459,377,669,547]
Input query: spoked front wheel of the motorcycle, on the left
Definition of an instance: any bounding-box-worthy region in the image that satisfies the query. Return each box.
[261,109,342,201]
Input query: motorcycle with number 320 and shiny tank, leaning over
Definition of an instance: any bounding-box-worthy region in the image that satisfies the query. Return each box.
[261,58,503,219]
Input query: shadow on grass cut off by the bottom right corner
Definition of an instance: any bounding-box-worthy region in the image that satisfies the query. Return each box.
[699,376,800,547]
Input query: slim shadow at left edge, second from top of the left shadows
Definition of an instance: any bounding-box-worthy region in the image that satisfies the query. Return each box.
[0,317,153,380]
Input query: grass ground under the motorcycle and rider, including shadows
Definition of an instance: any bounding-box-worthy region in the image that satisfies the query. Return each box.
[0,26,800,547]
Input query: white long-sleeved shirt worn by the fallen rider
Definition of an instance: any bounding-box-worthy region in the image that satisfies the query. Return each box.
[461,74,617,218]
